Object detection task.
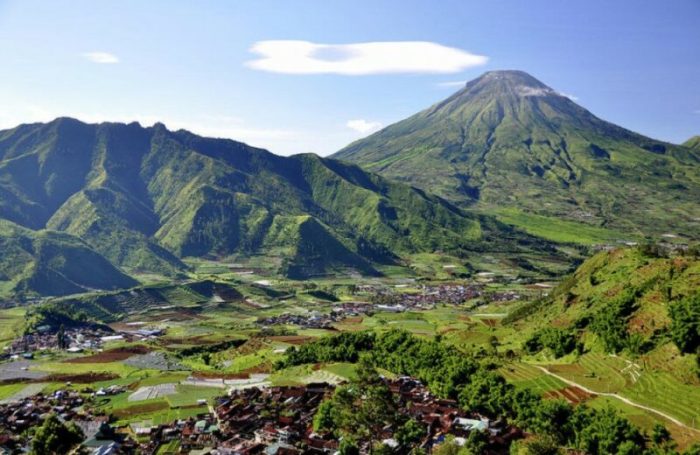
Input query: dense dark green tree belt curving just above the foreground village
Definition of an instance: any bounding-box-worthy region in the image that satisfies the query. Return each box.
[285,330,696,454]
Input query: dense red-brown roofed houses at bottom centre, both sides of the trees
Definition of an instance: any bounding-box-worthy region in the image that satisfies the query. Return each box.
[135,377,522,455]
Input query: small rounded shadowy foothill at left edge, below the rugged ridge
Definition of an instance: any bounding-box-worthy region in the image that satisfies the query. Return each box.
[0,220,137,296]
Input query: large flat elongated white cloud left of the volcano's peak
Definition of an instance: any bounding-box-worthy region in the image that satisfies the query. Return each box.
[246,40,488,76]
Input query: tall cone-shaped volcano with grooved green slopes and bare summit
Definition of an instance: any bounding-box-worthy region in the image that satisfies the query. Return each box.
[333,71,700,237]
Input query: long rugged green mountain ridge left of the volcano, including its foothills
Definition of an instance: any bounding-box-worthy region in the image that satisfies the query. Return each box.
[0,118,554,296]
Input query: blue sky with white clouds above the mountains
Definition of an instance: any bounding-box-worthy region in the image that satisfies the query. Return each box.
[0,0,700,155]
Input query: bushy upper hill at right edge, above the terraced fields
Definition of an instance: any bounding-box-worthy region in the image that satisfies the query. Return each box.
[506,245,700,382]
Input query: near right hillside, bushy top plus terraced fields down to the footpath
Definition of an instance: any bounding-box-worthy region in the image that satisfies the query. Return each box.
[504,246,700,432]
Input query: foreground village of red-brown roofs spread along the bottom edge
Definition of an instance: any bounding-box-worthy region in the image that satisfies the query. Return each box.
[0,377,521,455]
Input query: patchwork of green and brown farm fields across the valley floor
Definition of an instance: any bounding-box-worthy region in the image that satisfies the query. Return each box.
[0,249,700,452]
